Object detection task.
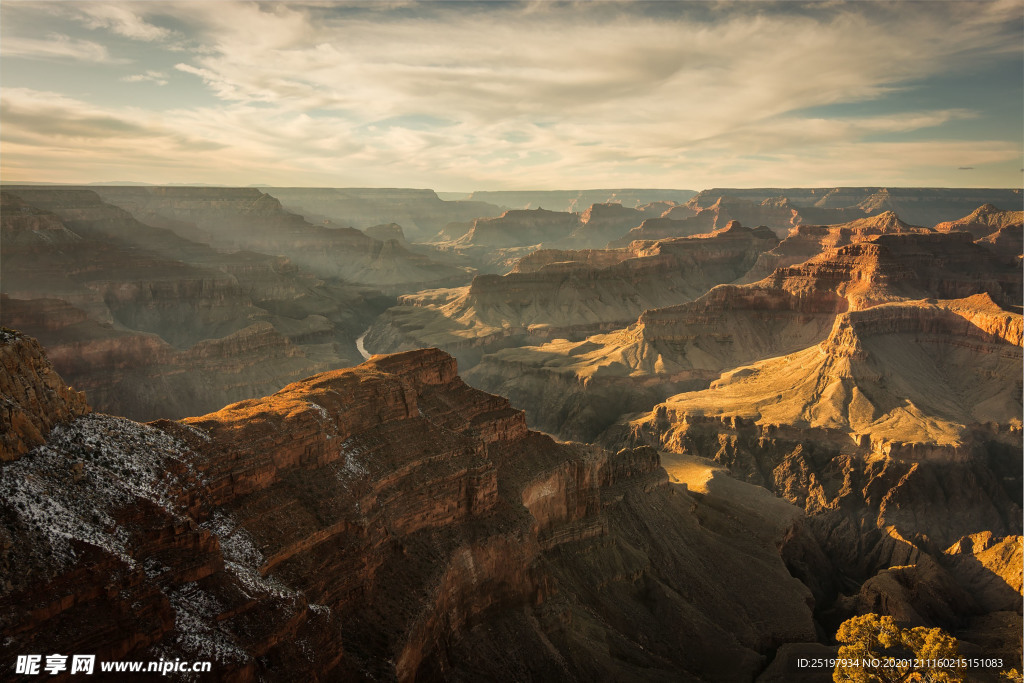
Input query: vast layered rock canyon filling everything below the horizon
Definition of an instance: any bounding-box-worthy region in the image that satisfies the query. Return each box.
[0,185,1024,683]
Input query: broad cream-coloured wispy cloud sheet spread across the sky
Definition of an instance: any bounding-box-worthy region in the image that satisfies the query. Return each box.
[2,0,1022,187]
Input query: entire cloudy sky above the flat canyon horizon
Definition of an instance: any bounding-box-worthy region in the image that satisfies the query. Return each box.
[0,0,1024,191]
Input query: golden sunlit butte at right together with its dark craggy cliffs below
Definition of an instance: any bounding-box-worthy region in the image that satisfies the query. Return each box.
[606,295,1024,649]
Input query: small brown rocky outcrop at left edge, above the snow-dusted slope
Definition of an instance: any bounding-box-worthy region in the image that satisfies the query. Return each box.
[0,328,89,462]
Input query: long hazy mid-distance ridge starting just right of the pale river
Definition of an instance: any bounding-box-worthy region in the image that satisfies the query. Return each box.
[366,223,776,374]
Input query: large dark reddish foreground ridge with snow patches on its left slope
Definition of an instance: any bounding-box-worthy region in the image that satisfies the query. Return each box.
[0,339,814,681]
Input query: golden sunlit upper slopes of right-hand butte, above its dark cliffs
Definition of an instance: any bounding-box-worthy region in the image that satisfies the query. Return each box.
[622,295,1022,454]
